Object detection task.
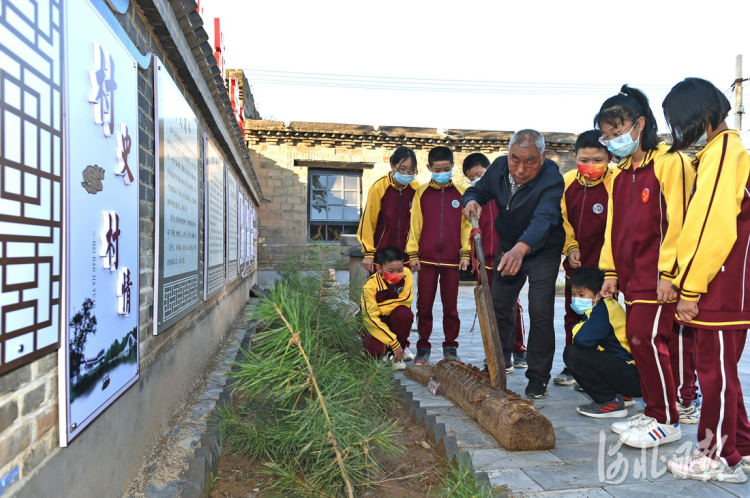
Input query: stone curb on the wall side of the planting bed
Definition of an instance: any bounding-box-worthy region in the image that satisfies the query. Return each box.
[181,322,258,498]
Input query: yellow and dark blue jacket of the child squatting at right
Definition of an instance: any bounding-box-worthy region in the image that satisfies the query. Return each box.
[573,297,635,364]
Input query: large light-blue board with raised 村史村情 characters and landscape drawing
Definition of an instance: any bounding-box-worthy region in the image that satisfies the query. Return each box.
[60,0,140,445]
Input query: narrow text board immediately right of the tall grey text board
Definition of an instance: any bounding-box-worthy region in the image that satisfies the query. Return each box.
[203,133,225,300]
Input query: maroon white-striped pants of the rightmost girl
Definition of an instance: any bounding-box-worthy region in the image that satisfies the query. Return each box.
[695,328,750,466]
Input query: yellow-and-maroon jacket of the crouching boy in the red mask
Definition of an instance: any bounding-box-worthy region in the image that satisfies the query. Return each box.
[362,267,413,349]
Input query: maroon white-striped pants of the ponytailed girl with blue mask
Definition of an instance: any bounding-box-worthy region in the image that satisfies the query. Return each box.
[624,302,680,424]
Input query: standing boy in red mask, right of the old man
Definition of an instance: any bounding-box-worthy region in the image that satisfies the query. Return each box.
[552,130,612,386]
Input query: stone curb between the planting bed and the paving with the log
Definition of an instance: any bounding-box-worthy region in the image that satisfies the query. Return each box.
[393,379,492,492]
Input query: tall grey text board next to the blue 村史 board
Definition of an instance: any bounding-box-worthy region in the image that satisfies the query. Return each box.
[154,59,202,334]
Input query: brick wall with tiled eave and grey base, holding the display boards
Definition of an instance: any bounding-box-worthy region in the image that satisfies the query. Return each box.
[0,0,263,496]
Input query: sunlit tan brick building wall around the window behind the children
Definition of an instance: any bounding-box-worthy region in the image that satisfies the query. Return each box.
[250,120,575,270]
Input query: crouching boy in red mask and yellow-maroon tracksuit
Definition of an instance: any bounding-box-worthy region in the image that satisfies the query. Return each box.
[362,247,414,370]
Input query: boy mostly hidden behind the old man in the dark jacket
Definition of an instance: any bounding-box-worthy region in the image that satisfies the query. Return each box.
[463,152,528,373]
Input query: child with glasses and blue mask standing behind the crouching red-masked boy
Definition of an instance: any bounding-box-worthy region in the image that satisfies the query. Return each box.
[357,147,419,273]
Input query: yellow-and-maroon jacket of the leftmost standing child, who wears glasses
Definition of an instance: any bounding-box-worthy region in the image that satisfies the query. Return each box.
[357,173,419,258]
